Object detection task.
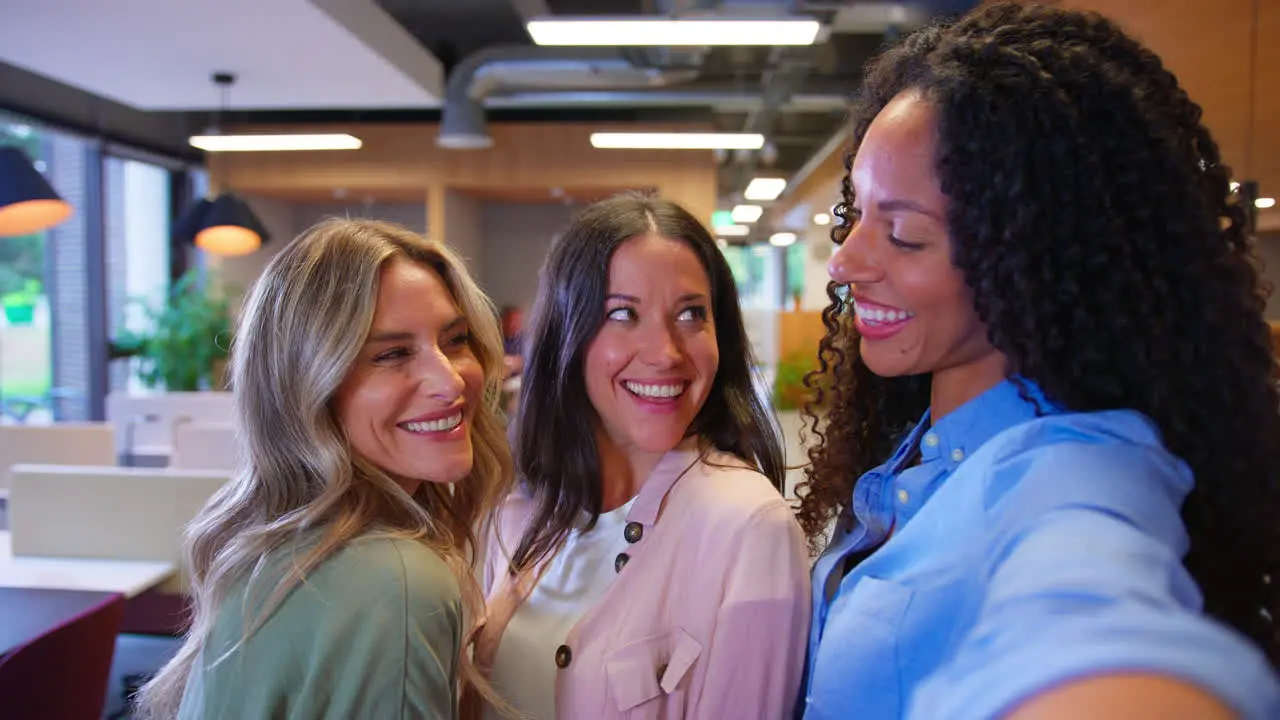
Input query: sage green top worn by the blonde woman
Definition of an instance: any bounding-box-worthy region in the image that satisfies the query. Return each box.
[178,534,462,720]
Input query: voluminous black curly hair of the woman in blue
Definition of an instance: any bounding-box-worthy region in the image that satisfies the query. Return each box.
[799,3,1280,662]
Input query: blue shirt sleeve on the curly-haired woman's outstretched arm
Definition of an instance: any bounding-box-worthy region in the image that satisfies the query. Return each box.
[909,442,1280,720]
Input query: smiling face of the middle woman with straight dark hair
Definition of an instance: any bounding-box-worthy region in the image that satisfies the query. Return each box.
[584,236,719,455]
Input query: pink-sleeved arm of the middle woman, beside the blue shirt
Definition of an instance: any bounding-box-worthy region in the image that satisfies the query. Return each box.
[689,503,810,720]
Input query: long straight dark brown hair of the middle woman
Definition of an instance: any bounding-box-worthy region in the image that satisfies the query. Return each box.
[511,193,785,571]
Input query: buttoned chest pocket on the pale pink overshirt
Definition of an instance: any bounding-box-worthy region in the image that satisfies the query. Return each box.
[604,628,703,719]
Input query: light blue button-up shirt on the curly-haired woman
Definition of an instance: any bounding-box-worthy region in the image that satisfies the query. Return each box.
[800,382,1280,720]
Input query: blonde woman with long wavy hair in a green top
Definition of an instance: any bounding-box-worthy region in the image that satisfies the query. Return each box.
[132,220,511,720]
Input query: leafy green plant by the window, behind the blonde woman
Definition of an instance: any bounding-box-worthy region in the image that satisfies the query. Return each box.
[113,270,232,392]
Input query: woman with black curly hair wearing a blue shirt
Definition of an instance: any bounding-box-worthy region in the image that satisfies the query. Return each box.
[800,4,1280,720]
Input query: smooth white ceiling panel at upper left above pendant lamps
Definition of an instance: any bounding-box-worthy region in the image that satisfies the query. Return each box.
[0,0,444,110]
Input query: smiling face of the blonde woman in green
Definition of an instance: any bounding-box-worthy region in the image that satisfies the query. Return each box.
[335,258,484,495]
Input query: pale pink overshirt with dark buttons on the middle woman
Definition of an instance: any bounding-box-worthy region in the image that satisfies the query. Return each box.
[476,450,810,720]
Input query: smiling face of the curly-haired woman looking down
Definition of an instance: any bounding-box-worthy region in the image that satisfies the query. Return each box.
[828,91,1005,389]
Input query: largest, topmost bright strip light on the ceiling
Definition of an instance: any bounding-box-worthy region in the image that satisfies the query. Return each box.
[525,18,822,47]
